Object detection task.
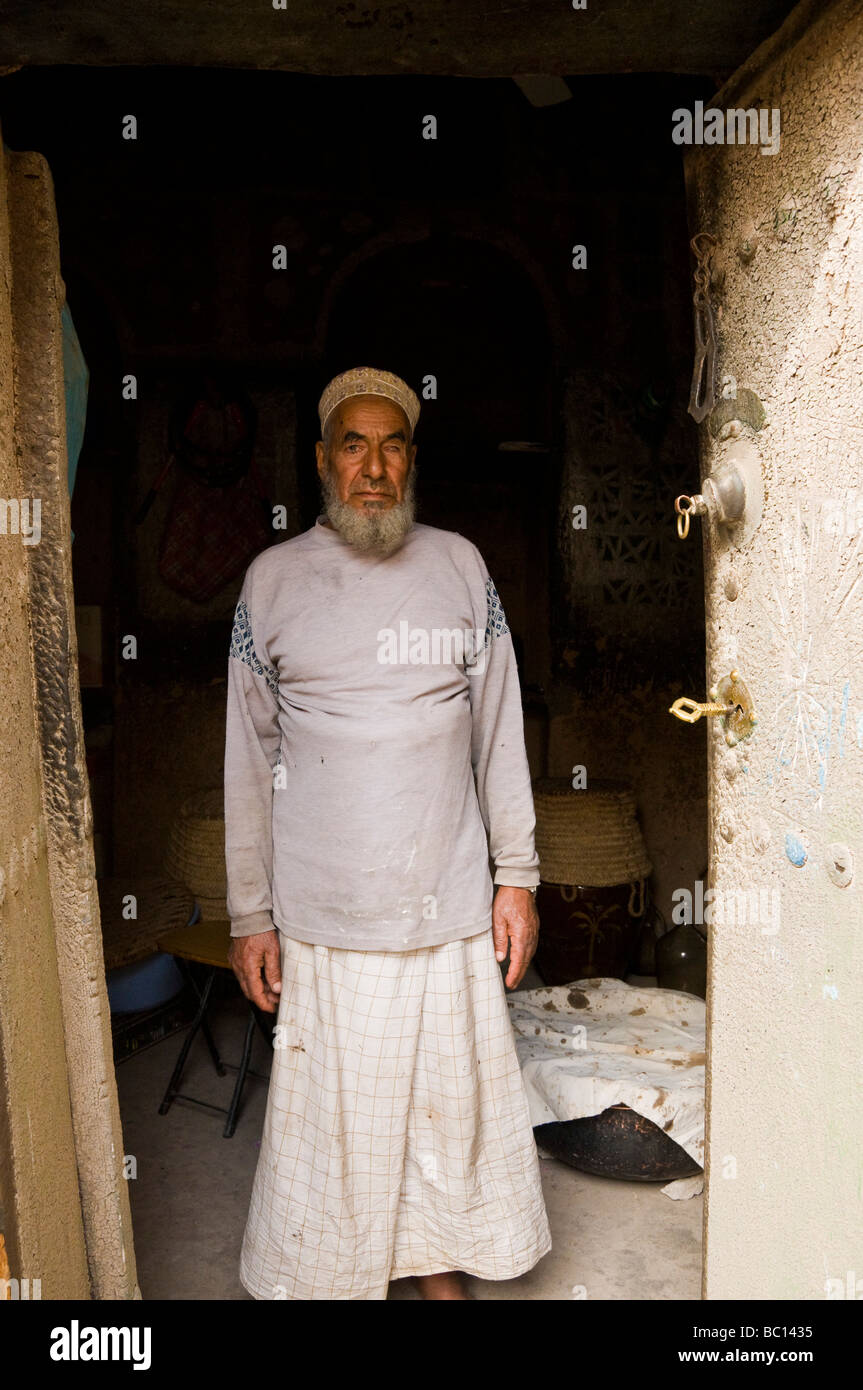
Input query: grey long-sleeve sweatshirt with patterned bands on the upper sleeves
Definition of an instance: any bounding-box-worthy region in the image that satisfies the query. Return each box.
[225,518,539,951]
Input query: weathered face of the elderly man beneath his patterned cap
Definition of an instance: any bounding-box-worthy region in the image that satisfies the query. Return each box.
[315,396,417,514]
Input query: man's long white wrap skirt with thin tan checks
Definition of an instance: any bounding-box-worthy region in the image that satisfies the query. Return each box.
[240,929,552,1300]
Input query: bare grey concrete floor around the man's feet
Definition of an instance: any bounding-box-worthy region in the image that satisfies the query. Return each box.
[117,980,702,1301]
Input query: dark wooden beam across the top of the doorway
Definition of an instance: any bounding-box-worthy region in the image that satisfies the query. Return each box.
[0,0,794,76]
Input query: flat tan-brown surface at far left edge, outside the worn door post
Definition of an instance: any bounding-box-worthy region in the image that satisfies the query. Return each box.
[0,146,89,1298]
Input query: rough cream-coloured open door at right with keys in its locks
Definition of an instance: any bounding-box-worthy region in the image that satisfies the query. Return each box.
[689,0,863,1300]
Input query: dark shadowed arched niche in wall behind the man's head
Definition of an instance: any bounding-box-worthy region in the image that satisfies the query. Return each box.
[299,227,564,695]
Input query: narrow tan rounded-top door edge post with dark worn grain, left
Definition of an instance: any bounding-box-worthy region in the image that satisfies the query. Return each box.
[8,154,136,1298]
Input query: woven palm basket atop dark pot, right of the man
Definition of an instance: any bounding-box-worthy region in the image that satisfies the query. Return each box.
[534,777,653,888]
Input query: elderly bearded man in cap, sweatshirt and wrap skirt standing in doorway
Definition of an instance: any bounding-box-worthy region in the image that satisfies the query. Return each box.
[225,367,550,1300]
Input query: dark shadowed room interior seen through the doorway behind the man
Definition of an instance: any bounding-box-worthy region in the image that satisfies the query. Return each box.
[3,68,710,1298]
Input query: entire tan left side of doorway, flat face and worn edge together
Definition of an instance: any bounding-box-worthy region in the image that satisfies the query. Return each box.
[0,150,139,1300]
